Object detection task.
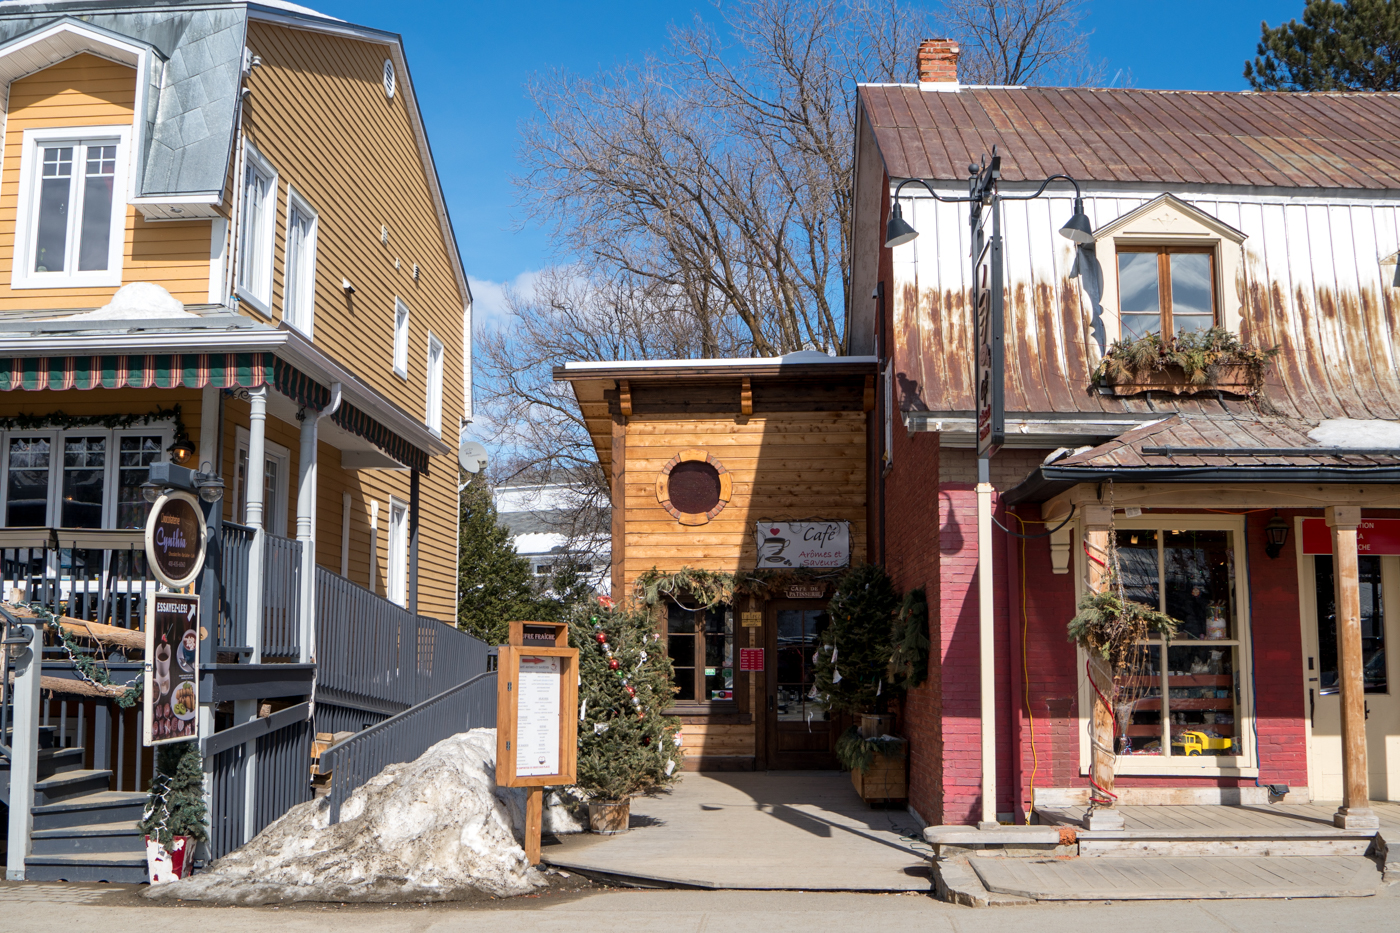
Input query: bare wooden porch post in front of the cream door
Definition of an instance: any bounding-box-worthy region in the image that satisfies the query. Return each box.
[1327,506,1380,829]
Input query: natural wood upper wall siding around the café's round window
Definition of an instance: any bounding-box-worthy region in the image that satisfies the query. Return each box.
[622,412,865,593]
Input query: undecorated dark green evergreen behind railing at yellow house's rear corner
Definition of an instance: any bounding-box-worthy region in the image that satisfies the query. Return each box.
[456,474,553,644]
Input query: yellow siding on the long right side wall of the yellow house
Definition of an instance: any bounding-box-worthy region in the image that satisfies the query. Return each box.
[244,22,465,621]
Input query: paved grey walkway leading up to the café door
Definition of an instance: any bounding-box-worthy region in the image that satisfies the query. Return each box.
[542,772,931,891]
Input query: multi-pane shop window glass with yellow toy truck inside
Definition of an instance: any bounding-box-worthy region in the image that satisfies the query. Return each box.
[1114,524,1245,758]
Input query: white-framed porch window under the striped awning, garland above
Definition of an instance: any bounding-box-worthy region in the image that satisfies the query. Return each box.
[0,426,172,528]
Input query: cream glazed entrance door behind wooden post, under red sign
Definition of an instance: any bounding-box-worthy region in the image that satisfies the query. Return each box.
[1299,555,1400,800]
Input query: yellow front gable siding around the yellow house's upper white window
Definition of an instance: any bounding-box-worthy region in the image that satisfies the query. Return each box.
[0,53,210,311]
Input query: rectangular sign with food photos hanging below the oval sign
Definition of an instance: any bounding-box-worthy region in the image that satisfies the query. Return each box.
[141,593,199,745]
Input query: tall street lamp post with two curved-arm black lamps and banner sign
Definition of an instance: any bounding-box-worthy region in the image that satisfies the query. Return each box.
[885,146,1093,829]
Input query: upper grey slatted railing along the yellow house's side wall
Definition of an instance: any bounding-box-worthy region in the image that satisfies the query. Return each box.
[316,567,490,713]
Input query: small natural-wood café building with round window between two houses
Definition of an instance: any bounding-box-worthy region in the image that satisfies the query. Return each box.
[554,353,875,770]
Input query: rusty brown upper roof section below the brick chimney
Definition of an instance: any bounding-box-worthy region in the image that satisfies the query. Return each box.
[860,85,1400,189]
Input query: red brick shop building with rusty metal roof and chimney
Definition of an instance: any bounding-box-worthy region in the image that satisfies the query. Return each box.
[847,43,1400,825]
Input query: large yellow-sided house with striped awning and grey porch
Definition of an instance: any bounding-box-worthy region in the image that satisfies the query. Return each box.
[0,0,484,881]
